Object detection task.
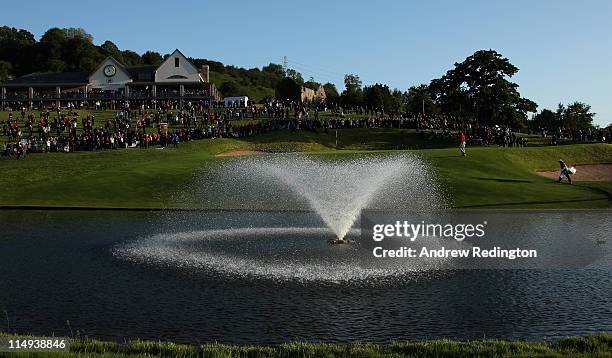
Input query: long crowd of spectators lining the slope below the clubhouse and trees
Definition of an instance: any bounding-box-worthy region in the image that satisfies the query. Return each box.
[0,101,612,158]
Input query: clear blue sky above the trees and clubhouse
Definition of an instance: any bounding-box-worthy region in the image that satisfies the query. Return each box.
[0,0,612,126]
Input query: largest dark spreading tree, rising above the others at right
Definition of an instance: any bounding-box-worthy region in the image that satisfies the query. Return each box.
[430,50,537,126]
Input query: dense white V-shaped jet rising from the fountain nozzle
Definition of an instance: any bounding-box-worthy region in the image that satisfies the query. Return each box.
[242,154,440,243]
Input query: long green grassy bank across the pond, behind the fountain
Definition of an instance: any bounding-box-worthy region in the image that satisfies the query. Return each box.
[0,129,612,209]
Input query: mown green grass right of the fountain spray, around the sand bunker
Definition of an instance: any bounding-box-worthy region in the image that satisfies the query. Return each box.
[419,144,612,209]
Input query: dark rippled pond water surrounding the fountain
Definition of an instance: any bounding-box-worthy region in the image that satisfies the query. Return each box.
[0,211,612,343]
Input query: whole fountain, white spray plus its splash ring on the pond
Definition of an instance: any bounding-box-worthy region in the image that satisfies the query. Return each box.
[115,153,444,281]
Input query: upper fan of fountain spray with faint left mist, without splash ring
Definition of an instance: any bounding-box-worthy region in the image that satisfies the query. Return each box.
[201,153,443,240]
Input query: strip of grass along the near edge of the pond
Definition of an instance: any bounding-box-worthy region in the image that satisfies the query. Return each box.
[0,334,612,358]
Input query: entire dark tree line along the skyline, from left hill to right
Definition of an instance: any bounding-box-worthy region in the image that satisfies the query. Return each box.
[0,26,595,128]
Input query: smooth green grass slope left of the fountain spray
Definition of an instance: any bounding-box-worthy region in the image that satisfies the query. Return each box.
[0,140,235,208]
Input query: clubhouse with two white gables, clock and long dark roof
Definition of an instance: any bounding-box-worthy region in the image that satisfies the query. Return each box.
[0,50,219,107]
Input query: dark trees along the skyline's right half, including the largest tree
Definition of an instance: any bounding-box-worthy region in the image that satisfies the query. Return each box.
[277,50,595,129]
